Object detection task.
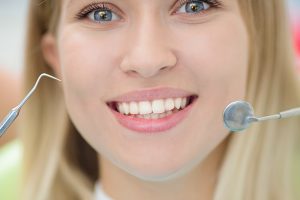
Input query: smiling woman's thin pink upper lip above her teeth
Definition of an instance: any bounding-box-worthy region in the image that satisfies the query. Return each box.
[108,87,196,102]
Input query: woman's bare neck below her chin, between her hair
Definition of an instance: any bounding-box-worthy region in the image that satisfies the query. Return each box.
[99,141,226,200]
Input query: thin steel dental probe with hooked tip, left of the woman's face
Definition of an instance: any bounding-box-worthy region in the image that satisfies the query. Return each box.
[0,73,61,137]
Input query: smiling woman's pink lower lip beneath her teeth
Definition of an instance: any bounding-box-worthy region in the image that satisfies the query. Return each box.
[110,99,197,134]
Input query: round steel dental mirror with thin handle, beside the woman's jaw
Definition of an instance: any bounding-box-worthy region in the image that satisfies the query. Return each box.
[223,101,300,132]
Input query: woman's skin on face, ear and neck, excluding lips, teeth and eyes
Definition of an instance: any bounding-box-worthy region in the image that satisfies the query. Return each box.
[42,0,249,200]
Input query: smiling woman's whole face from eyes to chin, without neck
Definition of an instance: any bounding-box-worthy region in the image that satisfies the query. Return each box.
[47,0,249,180]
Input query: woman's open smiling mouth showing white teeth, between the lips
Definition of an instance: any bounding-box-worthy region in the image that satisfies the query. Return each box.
[107,95,198,120]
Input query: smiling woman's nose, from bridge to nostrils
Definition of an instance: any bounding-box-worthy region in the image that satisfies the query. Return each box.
[120,23,177,78]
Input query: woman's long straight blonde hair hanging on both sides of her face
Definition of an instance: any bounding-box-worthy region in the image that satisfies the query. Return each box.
[22,0,300,200]
